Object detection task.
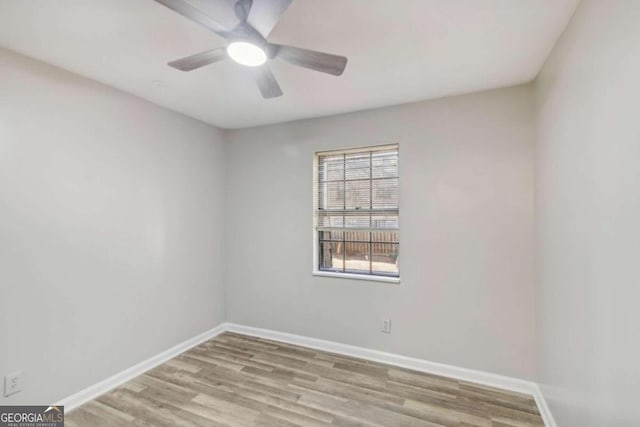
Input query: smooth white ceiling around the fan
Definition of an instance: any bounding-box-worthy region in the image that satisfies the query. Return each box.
[0,0,579,128]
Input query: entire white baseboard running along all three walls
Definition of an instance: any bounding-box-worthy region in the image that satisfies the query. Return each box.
[56,323,557,427]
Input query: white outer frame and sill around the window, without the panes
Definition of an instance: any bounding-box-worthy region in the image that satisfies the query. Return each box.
[311,143,400,284]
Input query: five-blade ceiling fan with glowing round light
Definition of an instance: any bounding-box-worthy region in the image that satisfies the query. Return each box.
[155,0,347,99]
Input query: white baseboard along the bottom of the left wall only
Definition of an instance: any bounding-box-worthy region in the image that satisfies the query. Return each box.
[56,323,227,412]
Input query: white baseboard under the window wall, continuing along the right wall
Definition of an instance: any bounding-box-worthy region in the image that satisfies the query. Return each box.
[227,323,557,427]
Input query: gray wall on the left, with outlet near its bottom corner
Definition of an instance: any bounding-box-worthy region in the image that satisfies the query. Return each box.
[0,49,225,405]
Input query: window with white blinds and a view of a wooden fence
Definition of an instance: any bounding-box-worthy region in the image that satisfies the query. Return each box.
[314,145,400,278]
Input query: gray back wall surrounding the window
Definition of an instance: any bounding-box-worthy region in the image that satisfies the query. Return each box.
[226,86,535,379]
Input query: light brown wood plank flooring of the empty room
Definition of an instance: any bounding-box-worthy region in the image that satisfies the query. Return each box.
[66,333,544,427]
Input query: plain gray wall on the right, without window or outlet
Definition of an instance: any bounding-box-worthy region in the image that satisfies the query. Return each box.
[536,0,640,427]
